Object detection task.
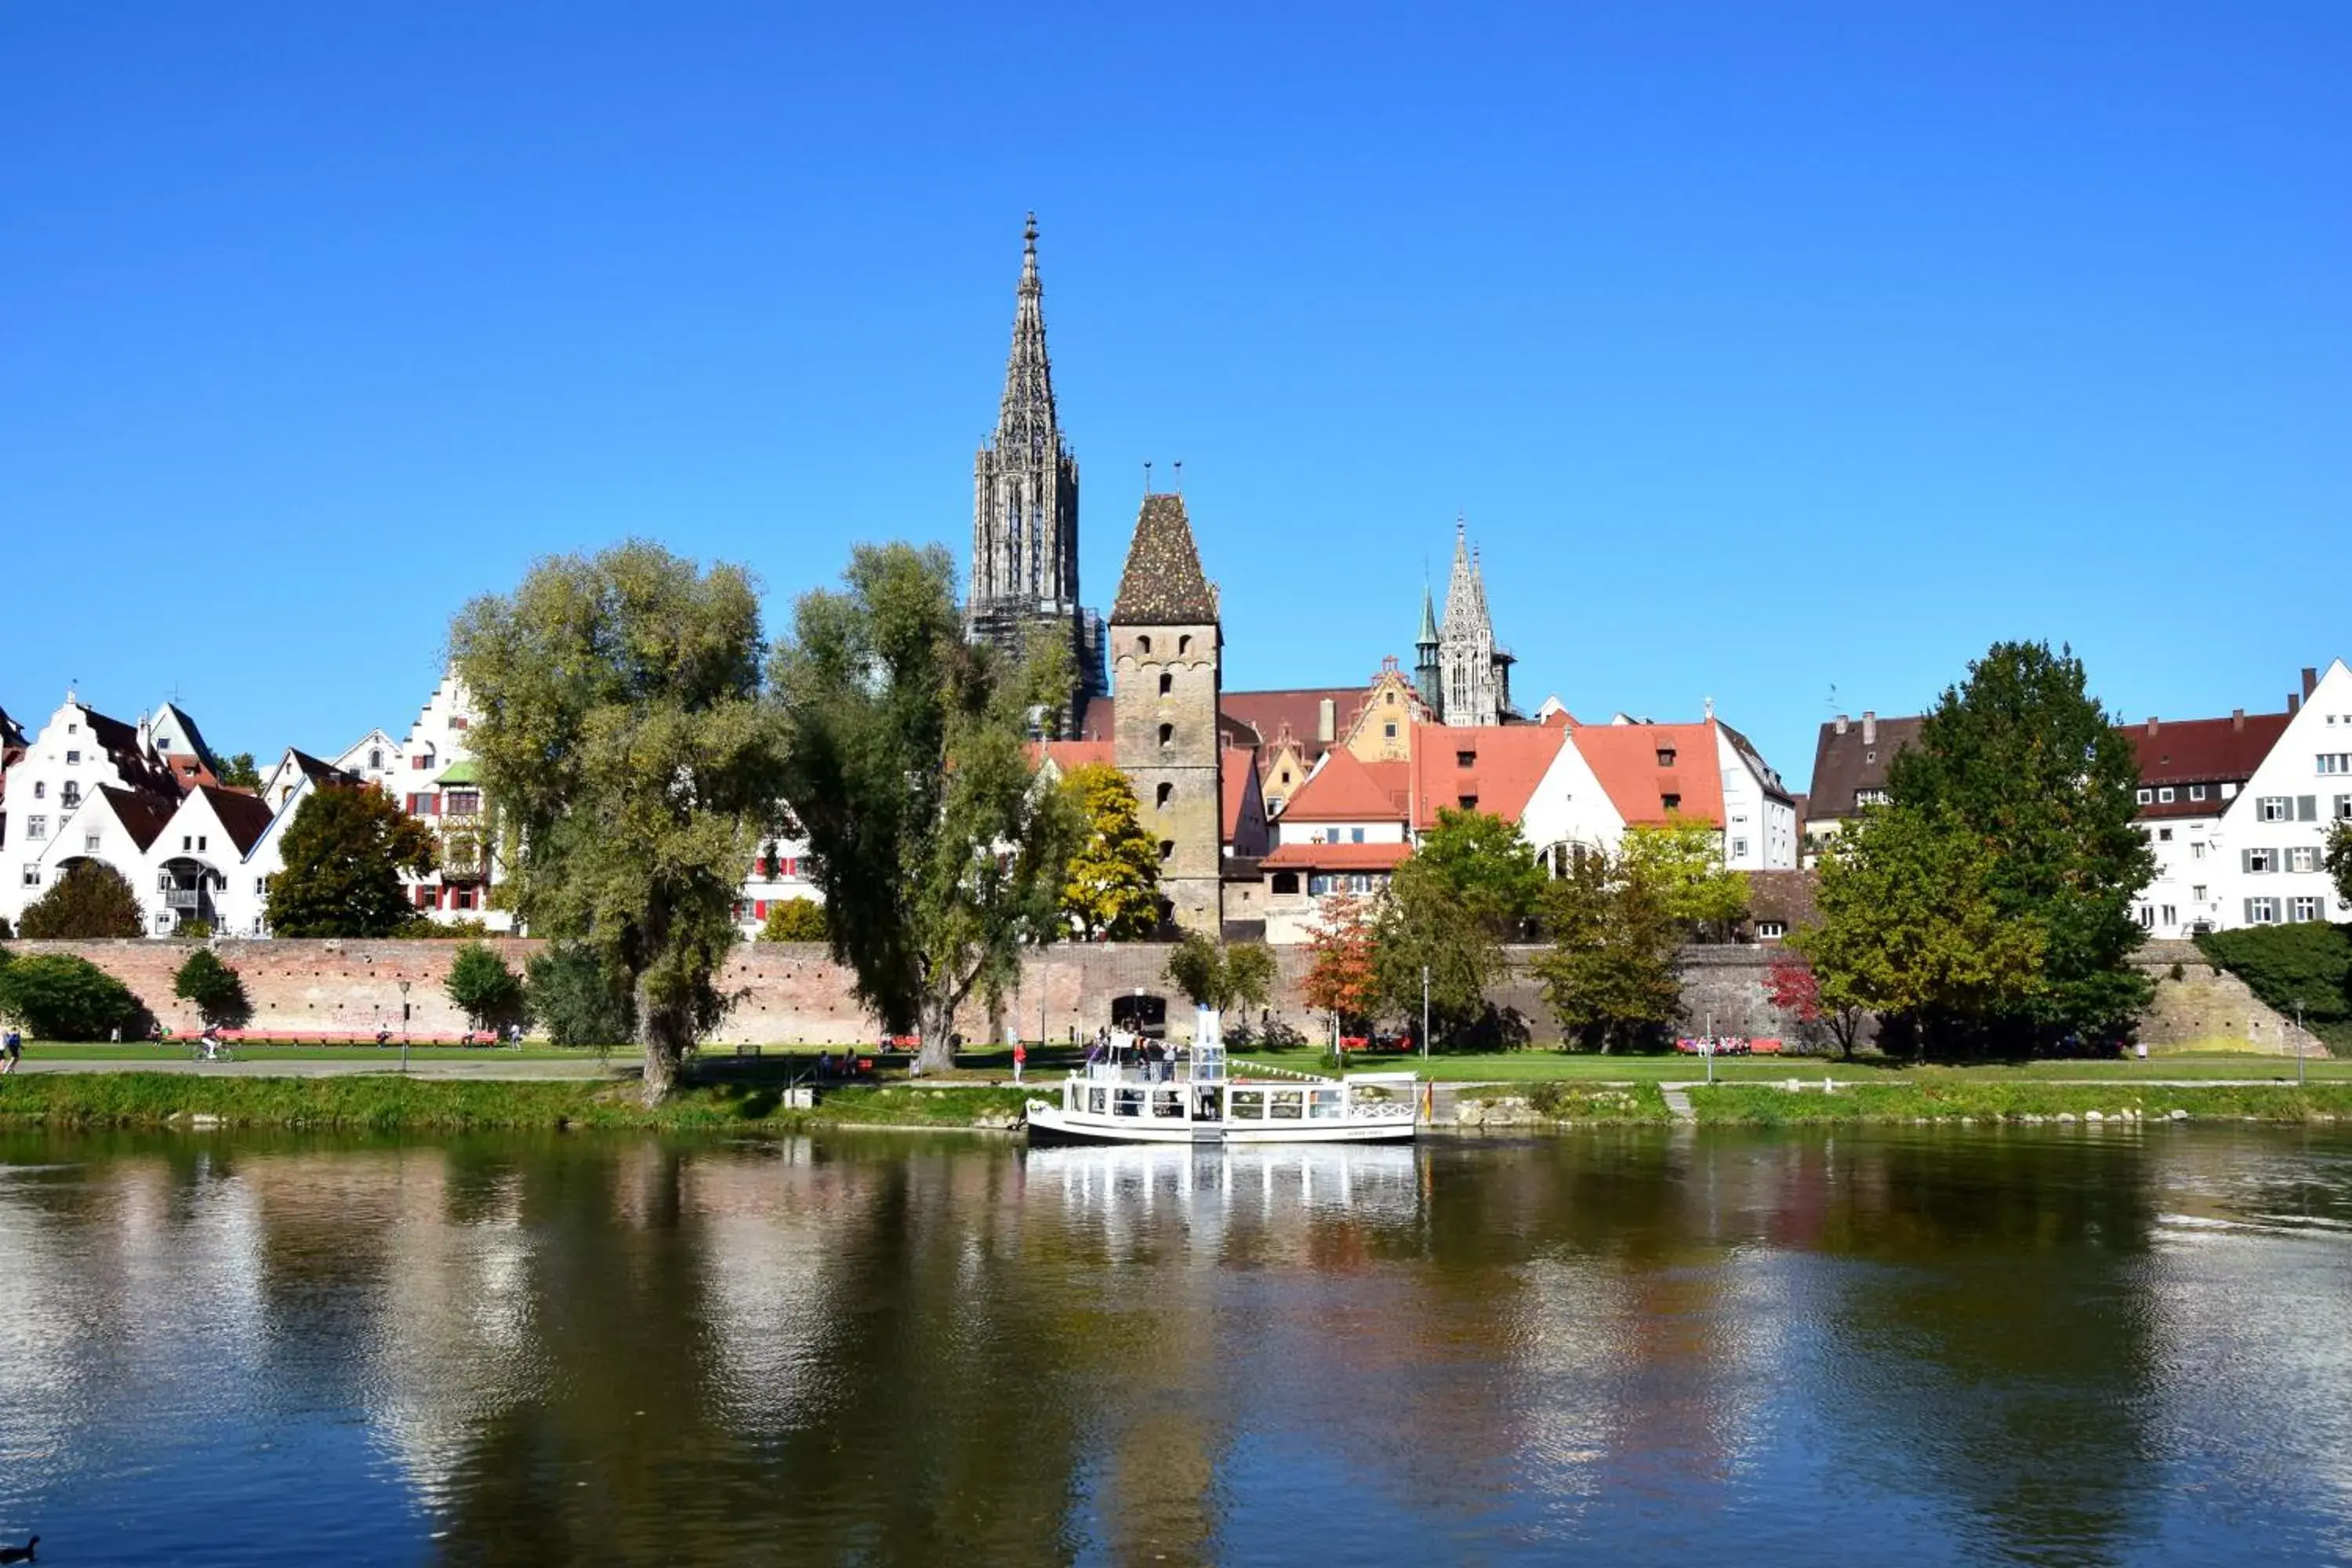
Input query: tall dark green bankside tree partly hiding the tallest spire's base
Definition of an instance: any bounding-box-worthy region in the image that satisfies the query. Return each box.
[776,546,1084,1072]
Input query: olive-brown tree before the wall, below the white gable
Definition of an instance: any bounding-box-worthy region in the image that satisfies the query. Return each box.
[1536,851,1682,1051]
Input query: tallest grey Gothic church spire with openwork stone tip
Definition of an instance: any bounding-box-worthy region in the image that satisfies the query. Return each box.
[964,212,1105,708]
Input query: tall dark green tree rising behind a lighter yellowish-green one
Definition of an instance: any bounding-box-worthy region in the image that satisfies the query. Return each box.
[1886,642,2157,1048]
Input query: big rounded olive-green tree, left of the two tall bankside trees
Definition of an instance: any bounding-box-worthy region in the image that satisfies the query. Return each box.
[449,541,783,1102]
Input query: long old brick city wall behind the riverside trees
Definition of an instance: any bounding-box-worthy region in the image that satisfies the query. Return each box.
[14,938,2288,1051]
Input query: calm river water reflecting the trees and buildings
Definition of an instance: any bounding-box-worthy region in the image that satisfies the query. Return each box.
[0,1126,2352,1566]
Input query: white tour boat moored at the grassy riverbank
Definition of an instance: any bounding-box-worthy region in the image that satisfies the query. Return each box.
[1028,1008,1418,1145]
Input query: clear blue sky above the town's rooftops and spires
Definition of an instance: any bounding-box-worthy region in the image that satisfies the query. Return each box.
[0,0,2352,787]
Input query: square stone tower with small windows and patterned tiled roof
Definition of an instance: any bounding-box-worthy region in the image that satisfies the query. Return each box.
[1110,496,1225,938]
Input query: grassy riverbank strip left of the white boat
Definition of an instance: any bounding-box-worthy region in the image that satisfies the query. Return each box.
[0,1072,1025,1133]
